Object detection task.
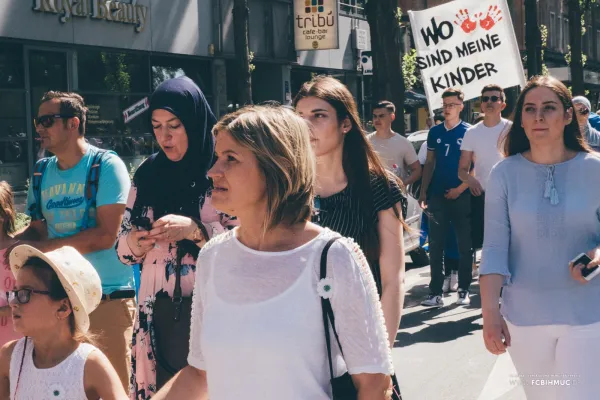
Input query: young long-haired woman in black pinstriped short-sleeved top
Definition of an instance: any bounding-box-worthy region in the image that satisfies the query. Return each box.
[294,76,406,347]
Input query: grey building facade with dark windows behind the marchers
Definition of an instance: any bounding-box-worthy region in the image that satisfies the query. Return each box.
[0,0,368,191]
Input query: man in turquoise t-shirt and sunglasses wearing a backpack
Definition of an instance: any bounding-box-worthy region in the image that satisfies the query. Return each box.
[13,92,137,390]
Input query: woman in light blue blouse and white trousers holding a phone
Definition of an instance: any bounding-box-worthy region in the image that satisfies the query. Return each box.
[480,77,600,400]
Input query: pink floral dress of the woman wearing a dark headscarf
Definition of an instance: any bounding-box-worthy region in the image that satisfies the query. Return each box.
[117,185,237,400]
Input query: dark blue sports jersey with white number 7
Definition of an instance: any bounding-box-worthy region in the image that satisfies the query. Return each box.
[427,121,471,196]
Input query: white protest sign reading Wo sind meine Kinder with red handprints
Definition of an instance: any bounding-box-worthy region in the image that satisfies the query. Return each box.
[408,0,525,113]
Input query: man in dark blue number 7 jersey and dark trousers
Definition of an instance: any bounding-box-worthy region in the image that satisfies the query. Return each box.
[419,88,473,307]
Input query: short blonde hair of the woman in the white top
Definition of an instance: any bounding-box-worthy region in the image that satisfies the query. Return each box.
[213,106,315,232]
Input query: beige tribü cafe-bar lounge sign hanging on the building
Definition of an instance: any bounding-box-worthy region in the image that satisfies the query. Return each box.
[294,0,339,51]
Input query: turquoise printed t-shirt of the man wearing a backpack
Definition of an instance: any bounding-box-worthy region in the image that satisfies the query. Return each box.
[27,145,135,294]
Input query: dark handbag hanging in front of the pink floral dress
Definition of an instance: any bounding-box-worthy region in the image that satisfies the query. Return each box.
[150,242,192,390]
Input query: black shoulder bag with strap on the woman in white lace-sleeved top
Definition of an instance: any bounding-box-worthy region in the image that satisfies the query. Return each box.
[319,236,402,400]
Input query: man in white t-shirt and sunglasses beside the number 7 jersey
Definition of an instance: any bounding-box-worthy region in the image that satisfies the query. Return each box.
[458,85,512,258]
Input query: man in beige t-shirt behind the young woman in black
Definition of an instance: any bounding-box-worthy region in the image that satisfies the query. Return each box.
[368,101,421,186]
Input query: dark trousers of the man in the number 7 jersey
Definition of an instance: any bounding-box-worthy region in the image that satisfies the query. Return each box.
[428,190,473,295]
